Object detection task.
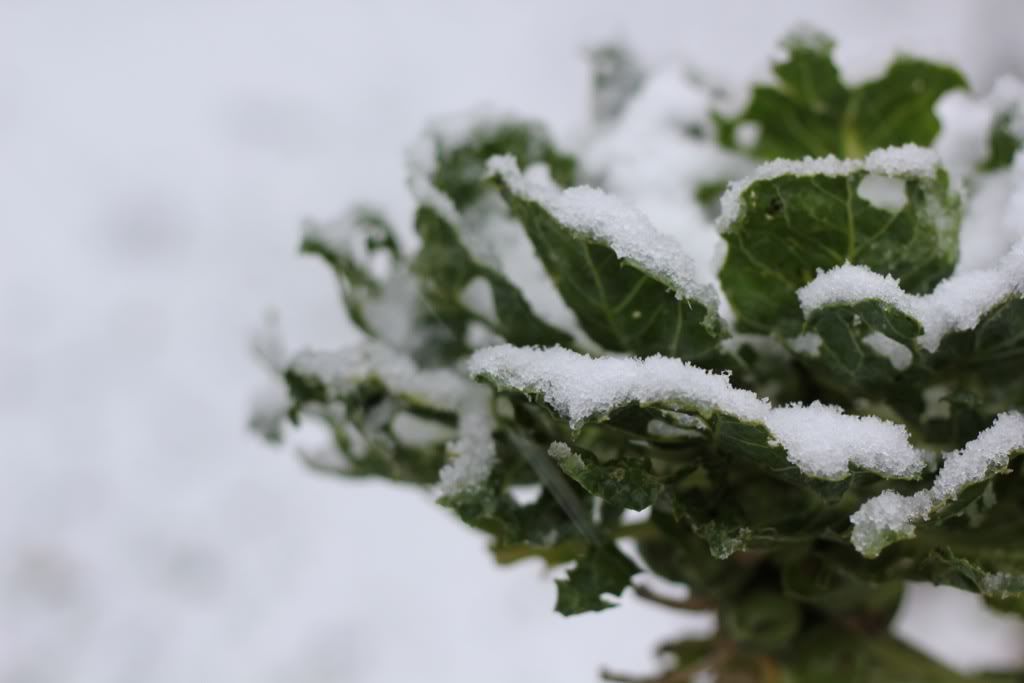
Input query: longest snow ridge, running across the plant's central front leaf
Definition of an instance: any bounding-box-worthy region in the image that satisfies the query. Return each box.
[468,345,927,479]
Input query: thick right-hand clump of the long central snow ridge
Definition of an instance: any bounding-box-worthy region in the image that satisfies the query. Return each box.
[764,401,925,479]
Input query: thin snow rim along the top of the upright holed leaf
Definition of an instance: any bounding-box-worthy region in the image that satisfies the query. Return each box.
[718,144,939,232]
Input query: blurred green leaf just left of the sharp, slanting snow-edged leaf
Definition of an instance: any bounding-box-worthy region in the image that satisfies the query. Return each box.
[413,207,572,345]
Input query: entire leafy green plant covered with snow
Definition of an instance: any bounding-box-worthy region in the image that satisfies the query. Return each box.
[254,31,1024,683]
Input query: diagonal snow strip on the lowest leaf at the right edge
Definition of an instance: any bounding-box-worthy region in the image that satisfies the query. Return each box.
[850,412,1024,557]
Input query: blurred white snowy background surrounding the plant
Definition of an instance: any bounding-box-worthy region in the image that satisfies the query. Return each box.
[0,0,1024,683]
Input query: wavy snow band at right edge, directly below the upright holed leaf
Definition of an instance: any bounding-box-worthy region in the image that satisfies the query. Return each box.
[797,241,1024,351]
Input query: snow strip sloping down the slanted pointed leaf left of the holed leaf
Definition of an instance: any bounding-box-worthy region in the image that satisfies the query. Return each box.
[487,156,718,311]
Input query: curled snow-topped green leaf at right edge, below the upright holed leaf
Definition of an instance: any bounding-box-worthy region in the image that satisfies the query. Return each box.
[800,259,1024,419]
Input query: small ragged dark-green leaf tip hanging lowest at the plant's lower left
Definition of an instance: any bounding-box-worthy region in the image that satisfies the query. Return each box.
[555,544,640,616]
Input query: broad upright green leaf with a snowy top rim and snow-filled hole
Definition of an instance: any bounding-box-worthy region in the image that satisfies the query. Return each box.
[719,153,959,337]
